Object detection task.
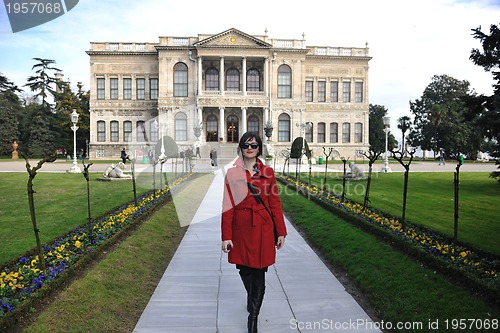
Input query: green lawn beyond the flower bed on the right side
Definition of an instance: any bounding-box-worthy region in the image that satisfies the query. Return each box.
[301,172,500,255]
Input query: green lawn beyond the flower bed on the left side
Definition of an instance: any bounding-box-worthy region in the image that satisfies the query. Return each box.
[0,172,182,265]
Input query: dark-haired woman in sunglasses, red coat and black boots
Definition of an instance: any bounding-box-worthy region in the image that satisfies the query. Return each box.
[221,132,286,333]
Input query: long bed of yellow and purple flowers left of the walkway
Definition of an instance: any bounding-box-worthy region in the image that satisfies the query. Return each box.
[0,174,190,331]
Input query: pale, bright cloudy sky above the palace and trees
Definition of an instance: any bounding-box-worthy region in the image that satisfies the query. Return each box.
[0,0,500,138]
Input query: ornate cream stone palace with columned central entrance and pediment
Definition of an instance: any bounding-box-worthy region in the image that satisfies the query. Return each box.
[87,28,371,159]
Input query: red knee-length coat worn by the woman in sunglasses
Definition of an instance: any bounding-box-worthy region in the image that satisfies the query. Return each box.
[221,158,286,268]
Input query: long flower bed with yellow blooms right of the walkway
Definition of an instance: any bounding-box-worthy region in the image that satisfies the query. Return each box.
[276,174,500,303]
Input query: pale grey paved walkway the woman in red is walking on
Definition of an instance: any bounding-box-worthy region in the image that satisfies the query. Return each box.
[133,169,380,333]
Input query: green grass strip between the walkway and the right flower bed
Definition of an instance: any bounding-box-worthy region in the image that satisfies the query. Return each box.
[280,184,500,332]
